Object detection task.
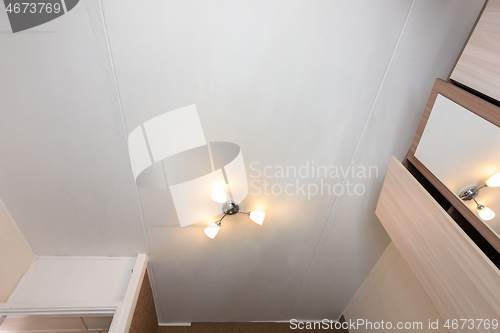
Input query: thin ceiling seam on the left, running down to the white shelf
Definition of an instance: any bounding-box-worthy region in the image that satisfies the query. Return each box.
[95,0,162,322]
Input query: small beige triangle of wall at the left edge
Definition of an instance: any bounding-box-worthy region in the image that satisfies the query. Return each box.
[0,201,35,303]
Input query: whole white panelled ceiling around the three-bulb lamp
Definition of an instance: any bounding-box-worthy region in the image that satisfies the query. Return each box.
[0,0,484,323]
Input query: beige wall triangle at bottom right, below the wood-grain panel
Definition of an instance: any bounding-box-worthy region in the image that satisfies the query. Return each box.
[344,243,448,332]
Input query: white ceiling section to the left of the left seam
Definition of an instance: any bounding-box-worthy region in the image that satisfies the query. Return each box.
[0,1,148,256]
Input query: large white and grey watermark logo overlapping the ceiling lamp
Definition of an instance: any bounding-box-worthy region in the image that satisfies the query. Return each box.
[128,104,248,230]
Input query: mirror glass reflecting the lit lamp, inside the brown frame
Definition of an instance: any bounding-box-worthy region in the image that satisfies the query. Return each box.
[415,94,500,235]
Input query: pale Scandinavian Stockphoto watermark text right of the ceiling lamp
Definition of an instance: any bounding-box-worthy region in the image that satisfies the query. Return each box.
[249,161,379,200]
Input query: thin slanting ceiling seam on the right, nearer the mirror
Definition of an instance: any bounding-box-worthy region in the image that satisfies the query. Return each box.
[290,0,415,318]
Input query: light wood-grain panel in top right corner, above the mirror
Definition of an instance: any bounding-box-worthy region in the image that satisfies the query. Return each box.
[451,0,500,101]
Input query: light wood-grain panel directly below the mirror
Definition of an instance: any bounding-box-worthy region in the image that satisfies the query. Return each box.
[376,157,500,332]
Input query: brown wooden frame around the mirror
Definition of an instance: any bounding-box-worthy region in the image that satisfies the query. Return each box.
[406,79,500,252]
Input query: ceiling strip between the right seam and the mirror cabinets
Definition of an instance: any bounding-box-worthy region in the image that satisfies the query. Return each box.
[293,0,484,319]
